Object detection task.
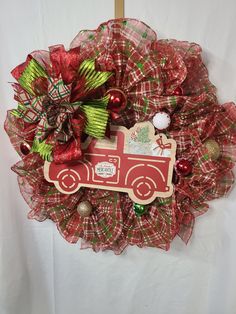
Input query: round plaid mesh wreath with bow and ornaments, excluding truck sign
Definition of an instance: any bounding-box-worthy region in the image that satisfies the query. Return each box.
[5,19,236,254]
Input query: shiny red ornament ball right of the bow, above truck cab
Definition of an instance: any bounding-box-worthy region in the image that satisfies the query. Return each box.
[106,88,127,112]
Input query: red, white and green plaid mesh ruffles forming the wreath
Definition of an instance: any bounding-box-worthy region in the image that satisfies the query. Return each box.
[5,19,236,254]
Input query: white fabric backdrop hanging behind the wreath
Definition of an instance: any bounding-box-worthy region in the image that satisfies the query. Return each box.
[0,0,236,314]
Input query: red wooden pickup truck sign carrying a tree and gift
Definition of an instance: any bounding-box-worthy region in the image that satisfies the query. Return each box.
[44,122,176,204]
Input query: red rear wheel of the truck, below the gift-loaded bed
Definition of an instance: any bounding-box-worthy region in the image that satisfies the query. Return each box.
[132,178,155,201]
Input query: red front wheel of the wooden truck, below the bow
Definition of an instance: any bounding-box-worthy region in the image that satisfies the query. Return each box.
[57,169,80,193]
